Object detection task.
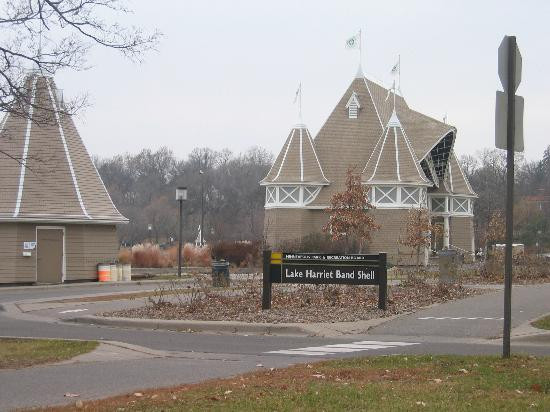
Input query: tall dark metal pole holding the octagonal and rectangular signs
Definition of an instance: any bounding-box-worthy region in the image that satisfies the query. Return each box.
[502,36,516,358]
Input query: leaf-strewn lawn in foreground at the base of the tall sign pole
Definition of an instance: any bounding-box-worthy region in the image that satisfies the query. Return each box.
[48,355,550,411]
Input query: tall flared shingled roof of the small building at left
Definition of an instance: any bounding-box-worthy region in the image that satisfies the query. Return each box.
[0,74,128,223]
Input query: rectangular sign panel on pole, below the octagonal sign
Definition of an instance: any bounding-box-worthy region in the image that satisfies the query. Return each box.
[495,91,524,152]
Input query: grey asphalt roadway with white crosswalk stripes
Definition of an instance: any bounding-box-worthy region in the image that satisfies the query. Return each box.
[0,285,550,410]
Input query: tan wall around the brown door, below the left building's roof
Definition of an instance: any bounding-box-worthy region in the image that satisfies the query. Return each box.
[0,223,119,283]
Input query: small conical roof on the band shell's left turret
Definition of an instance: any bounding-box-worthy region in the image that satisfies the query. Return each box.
[261,124,329,185]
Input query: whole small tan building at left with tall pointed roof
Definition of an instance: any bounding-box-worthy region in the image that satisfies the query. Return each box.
[0,74,128,283]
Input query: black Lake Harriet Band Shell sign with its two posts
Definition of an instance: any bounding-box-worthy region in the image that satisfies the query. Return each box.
[262,250,388,310]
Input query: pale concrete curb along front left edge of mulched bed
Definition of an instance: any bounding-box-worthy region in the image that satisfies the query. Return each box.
[67,315,312,336]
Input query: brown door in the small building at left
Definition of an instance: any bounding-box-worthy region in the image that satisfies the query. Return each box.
[36,229,63,283]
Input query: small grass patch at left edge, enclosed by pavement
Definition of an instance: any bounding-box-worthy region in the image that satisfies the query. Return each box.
[0,338,98,369]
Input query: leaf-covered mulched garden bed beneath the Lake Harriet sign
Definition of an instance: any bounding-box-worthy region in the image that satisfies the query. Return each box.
[102,281,487,323]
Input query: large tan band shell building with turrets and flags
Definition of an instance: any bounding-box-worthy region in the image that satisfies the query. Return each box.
[260,68,477,263]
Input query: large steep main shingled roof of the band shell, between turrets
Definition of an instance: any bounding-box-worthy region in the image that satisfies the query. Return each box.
[298,70,470,207]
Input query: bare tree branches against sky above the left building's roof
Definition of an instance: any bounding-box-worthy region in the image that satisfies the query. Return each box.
[0,0,160,117]
